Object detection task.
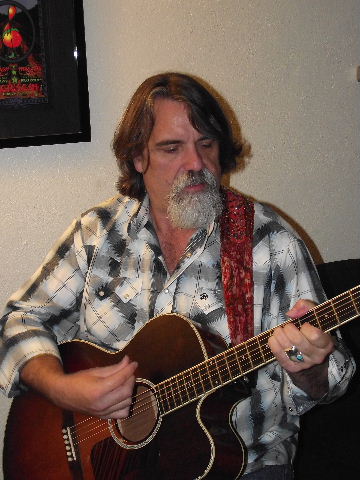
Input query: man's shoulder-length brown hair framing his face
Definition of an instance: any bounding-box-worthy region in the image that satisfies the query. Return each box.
[112,72,243,200]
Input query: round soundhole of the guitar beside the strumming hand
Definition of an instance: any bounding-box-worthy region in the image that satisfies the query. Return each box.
[111,380,159,448]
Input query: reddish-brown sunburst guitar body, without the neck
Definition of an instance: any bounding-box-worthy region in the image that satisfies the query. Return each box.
[4,314,246,480]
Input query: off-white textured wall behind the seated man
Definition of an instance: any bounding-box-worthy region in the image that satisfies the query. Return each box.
[0,0,360,476]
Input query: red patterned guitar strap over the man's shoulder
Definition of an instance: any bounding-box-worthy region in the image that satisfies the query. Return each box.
[220,188,254,345]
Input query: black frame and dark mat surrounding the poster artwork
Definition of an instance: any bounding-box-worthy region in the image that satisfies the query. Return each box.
[0,0,91,148]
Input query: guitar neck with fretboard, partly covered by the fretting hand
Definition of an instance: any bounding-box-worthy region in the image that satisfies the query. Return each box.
[156,285,360,414]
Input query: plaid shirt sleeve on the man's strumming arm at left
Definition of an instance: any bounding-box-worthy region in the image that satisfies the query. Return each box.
[0,221,87,396]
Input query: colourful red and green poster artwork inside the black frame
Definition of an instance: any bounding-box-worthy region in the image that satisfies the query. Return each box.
[0,0,48,106]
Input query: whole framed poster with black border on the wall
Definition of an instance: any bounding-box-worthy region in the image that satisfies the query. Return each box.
[0,0,91,148]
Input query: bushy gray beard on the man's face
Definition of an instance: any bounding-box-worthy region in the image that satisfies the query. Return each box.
[167,170,223,229]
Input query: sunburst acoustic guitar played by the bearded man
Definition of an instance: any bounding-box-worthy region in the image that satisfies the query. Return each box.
[4,285,360,480]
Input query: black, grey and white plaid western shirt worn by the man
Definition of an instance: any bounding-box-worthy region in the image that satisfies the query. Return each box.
[0,196,354,472]
